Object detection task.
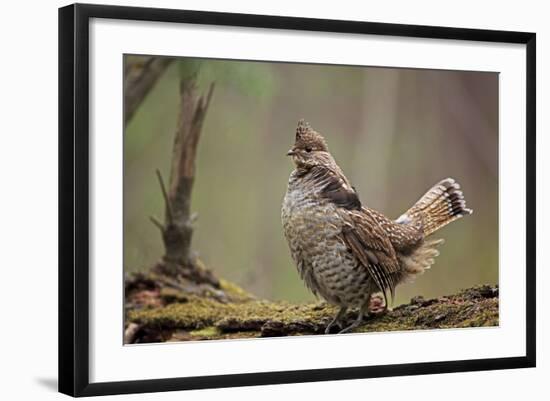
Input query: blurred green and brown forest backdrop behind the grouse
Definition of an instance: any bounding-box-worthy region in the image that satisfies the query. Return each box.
[124,56,498,305]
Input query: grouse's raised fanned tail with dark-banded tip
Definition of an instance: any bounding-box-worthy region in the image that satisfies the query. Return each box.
[397,178,472,236]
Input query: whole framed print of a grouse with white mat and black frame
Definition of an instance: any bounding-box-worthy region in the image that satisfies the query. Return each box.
[59,4,536,396]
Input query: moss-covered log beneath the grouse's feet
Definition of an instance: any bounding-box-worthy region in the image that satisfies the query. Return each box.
[125,276,499,343]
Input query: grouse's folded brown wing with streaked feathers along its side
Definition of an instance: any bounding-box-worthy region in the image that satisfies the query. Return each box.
[342,208,399,305]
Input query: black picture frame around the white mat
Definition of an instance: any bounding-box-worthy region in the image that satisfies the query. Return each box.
[59,4,536,396]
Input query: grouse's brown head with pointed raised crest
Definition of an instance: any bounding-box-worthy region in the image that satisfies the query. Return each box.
[287,120,332,169]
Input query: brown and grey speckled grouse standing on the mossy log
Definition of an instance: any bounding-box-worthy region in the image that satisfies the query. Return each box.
[281,119,472,334]
